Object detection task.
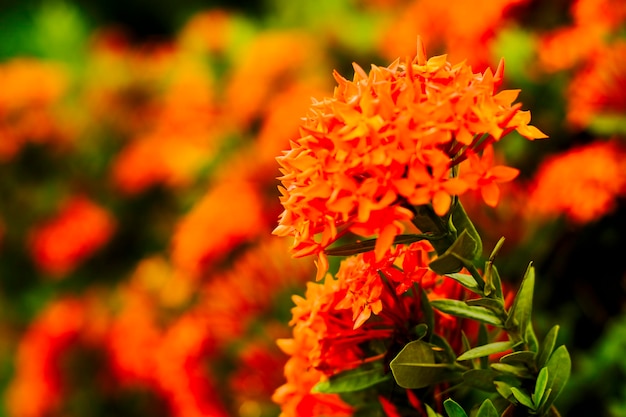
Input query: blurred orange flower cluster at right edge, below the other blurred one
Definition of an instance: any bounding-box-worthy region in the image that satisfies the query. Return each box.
[527,141,626,223]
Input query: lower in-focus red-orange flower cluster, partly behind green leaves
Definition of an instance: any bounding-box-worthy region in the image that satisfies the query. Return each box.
[274,242,476,417]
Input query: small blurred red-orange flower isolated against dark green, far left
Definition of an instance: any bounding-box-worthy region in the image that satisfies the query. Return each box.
[29,196,115,277]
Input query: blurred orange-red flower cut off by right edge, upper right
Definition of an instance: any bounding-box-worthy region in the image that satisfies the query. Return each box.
[567,41,626,128]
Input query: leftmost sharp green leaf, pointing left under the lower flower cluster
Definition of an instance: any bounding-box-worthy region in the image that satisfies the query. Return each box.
[312,362,391,394]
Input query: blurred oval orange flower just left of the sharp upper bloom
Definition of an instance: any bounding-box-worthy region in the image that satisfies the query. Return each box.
[171,180,265,277]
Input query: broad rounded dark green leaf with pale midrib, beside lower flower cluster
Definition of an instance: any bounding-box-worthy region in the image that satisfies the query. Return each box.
[389,340,452,389]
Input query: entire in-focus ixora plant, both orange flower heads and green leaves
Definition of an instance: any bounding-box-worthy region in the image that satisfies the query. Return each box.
[274,39,571,417]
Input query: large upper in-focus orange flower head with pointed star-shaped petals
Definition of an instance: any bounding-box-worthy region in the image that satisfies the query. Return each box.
[274,42,545,265]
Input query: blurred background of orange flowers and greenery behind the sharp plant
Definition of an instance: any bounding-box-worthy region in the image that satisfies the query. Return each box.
[0,0,626,417]
